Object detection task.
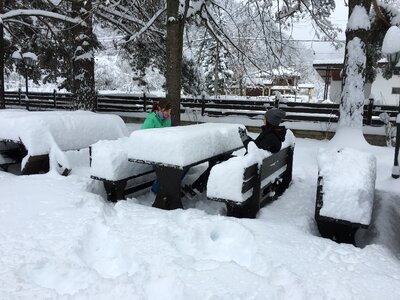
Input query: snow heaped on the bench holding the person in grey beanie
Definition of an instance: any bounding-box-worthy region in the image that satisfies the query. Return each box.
[207,130,295,202]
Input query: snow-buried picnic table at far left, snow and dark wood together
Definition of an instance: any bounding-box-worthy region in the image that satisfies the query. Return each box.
[0,109,128,175]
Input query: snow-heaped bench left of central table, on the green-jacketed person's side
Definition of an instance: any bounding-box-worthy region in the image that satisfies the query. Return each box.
[89,137,154,202]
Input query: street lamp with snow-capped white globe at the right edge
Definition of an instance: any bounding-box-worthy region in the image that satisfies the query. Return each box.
[382,26,400,178]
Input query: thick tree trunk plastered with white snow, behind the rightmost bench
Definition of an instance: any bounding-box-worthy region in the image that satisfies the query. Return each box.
[339,0,371,127]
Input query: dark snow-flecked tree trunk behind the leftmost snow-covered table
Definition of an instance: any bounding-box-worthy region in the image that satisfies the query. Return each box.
[72,0,96,111]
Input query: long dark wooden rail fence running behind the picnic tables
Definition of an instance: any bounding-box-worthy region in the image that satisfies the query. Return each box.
[5,90,398,126]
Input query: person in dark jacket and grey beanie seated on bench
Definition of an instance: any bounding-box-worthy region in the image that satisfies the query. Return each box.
[239,108,286,153]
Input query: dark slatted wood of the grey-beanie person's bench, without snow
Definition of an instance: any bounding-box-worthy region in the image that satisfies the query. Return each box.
[208,146,294,218]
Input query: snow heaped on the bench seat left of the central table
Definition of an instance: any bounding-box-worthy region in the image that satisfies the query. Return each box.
[90,137,152,181]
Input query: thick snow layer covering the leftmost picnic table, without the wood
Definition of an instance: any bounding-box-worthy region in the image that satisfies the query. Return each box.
[0,110,128,156]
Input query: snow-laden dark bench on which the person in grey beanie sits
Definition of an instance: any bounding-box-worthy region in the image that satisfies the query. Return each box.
[207,130,294,218]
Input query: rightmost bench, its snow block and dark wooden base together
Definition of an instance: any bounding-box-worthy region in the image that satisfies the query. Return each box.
[315,148,376,244]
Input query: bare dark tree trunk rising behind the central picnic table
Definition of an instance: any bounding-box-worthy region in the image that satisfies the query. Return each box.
[166,0,189,125]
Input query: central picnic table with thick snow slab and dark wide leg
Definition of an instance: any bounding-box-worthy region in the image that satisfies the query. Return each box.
[128,123,244,209]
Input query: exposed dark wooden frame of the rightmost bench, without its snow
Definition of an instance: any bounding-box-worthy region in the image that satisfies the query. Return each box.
[315,176,368,245]
